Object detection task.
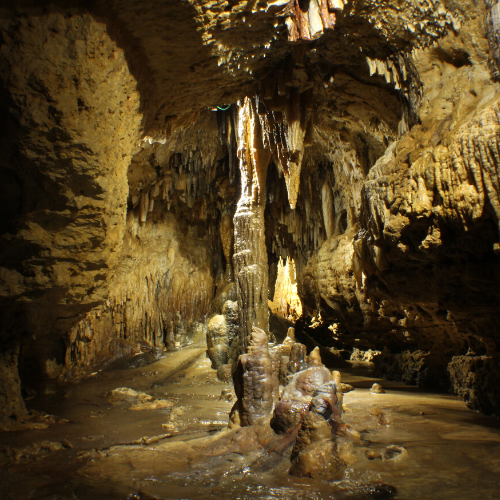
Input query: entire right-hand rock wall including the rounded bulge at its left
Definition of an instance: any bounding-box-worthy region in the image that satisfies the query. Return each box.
[299,9,500,407]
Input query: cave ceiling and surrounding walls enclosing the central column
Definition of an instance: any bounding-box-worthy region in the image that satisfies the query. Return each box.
[0,0,500,426]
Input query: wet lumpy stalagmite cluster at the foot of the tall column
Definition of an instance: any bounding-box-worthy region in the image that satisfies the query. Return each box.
[230,322,352,477]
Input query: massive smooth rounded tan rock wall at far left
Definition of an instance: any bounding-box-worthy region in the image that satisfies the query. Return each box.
[0,11,142,394]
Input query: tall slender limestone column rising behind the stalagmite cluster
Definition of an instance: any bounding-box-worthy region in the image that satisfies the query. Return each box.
[233,97,271,354]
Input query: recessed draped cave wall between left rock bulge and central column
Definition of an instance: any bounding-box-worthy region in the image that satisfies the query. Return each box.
[47,111,232,380]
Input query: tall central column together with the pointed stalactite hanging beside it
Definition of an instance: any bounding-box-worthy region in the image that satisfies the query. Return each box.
[231,79,312,351]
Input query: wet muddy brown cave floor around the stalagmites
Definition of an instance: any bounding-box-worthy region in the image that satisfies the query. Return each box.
[0,348,500,500]
